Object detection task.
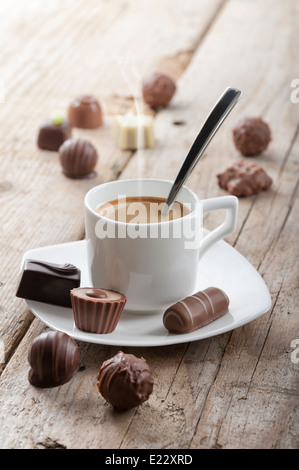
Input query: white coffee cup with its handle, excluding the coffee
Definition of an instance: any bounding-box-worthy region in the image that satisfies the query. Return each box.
[85,179,238,314]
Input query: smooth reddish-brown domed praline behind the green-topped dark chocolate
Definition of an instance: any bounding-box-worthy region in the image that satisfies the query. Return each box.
[68,95,103,129]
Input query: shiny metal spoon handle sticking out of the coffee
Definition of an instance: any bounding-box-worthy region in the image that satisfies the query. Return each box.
[163,88,241,212]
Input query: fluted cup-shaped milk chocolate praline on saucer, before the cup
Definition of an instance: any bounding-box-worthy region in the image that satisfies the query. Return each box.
[71,287,127,334]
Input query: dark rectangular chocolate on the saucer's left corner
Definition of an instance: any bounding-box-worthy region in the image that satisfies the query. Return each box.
[16,259,81,307]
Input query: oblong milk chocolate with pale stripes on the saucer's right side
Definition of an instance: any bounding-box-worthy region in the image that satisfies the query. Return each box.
[163,287,229,334]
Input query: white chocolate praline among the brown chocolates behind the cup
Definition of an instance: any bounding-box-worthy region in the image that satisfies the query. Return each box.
[112,113,155,150]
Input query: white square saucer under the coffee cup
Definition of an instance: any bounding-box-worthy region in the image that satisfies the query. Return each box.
[22,240,271,346]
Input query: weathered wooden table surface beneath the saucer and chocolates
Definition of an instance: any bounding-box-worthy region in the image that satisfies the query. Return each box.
[0,0,299,449]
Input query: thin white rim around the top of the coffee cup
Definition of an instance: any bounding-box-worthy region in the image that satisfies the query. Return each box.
[84,178,200,226]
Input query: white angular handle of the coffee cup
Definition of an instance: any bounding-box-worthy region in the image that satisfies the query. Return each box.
[199,196,239,258]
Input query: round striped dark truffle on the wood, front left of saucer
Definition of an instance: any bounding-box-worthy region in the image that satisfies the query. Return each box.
[28,331,80,388]
